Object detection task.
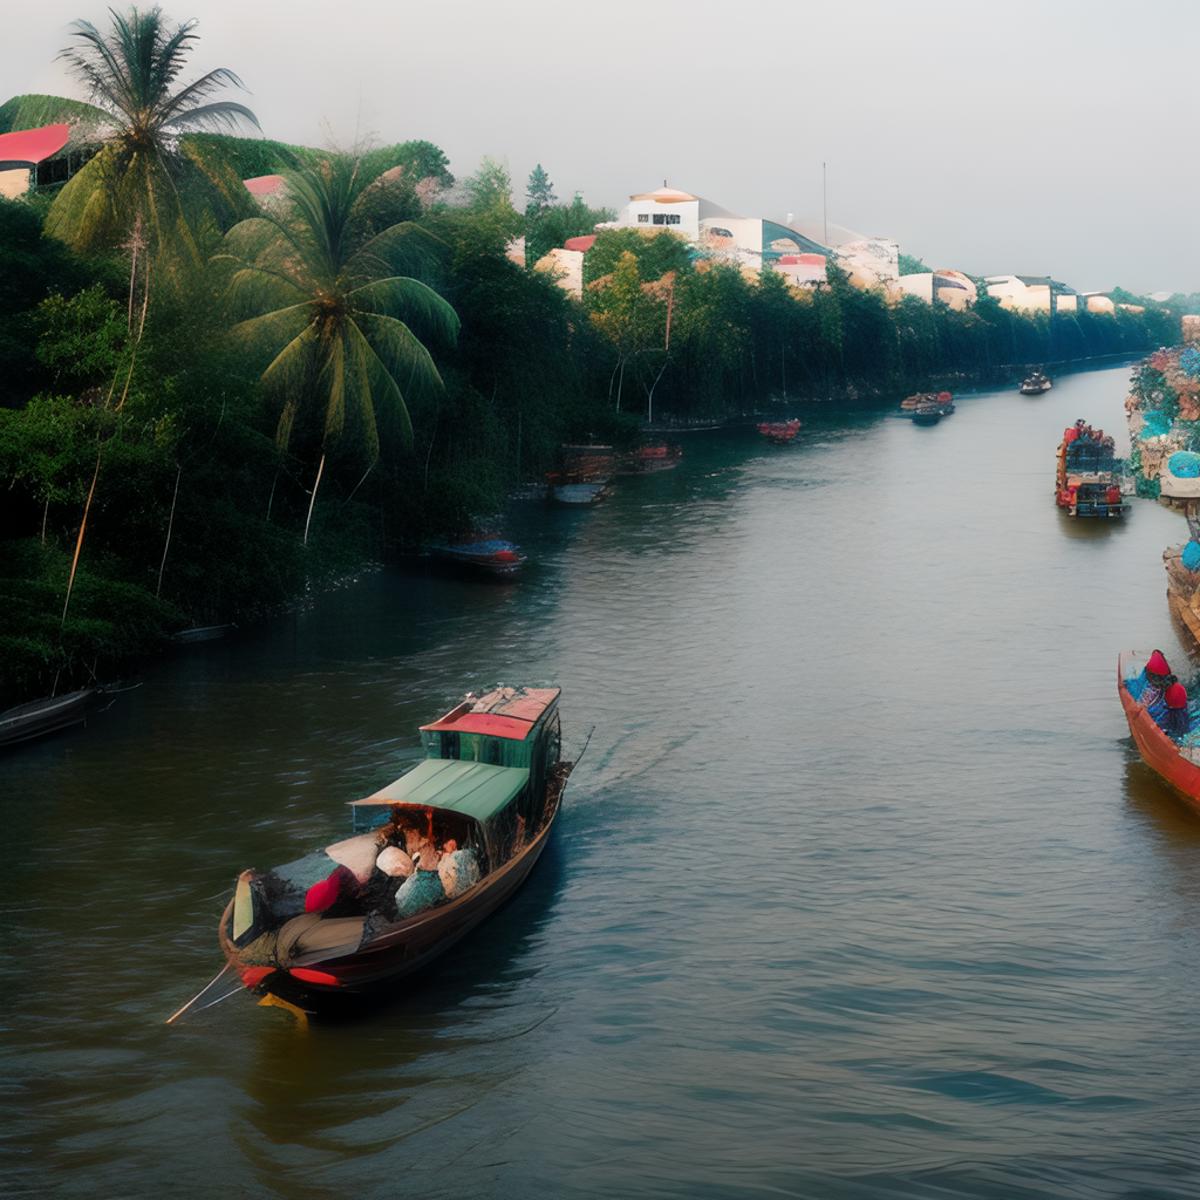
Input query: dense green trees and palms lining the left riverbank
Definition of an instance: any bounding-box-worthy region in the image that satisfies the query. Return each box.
[0,10,1176,702]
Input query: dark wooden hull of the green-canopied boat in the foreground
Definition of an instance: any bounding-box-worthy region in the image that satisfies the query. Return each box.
[218,763,570,1013]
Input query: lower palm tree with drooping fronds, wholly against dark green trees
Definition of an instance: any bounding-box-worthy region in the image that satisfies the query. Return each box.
[217,155,458,544]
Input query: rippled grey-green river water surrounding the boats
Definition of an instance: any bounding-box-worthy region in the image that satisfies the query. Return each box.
[0,368,1200,1200]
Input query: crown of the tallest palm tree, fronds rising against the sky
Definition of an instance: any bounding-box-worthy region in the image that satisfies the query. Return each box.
[46,7,258,265]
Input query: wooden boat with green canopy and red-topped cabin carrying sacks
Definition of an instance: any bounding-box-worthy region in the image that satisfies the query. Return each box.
[218,688,574,1010]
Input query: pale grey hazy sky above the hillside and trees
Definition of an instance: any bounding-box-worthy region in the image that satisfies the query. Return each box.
[9,0,1200,292]
